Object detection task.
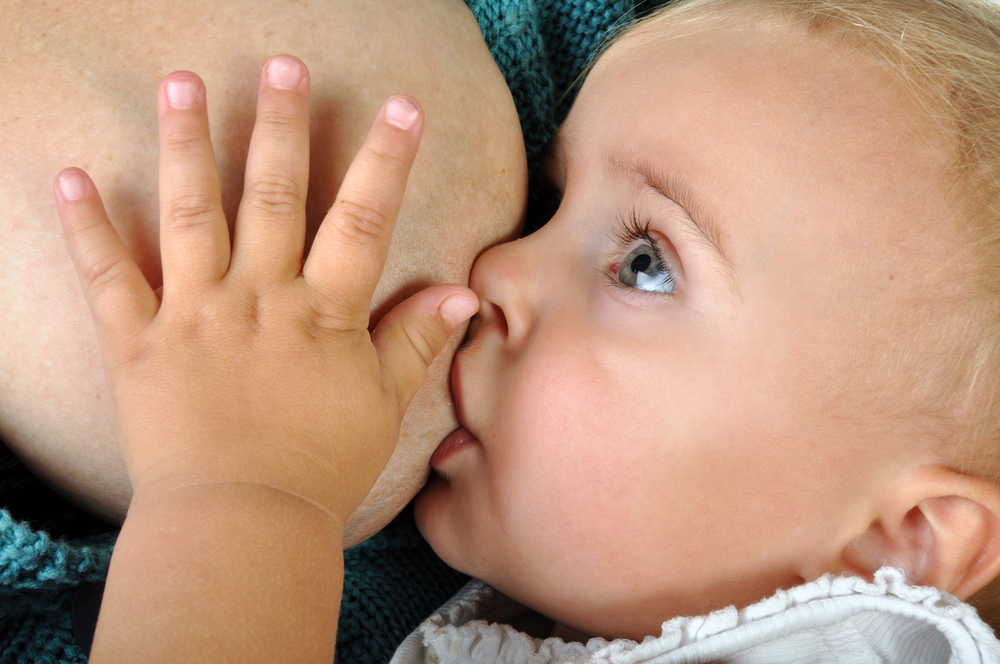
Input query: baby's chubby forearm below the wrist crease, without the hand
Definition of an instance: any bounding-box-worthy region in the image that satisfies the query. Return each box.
[91,484,344,664]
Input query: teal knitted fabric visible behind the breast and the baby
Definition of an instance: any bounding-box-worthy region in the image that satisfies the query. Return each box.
[0,0,636,664]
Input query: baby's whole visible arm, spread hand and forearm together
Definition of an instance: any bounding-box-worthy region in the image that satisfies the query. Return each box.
[56,65,470,664]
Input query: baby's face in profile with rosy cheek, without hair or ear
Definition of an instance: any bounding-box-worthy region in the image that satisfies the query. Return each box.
[417,13,956,638]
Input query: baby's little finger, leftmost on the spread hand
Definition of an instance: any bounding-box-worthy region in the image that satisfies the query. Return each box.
[55,168,159,343]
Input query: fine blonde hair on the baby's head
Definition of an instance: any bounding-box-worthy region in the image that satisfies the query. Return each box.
[606,0,1000,633]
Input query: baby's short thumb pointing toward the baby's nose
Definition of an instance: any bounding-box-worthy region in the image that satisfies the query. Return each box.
[372,285,479,413]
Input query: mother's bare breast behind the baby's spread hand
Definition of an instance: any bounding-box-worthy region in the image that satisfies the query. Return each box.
[0,0,526,545]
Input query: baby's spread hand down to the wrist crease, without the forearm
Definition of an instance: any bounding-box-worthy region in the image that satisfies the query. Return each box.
[56,57,478,526]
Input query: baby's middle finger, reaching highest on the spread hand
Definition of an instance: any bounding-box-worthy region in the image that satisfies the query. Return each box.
[233,55,309,280]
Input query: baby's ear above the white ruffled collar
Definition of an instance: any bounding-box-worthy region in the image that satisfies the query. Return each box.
[842,467,1000,600]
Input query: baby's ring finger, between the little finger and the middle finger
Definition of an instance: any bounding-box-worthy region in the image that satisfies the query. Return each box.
[159,71,229,297]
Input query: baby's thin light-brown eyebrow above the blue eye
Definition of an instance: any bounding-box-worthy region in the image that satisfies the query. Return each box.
[603,150,733,270]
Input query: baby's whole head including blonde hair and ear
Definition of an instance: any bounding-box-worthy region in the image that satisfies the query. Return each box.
[416,0,1000,640]
